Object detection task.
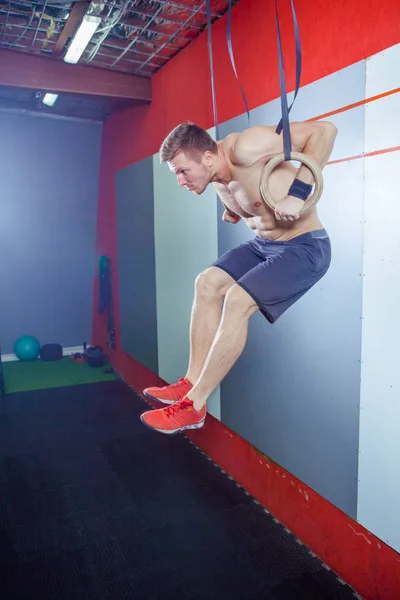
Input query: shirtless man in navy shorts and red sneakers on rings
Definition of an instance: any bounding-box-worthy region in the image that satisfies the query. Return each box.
[141,121,337,433]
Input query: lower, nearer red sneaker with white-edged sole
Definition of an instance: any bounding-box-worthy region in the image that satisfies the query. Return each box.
[140,398,207,433]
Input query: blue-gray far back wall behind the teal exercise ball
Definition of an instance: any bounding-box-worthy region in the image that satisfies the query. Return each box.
[0,112,102,354]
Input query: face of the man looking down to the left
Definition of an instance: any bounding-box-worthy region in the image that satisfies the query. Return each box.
[168,152,213,195]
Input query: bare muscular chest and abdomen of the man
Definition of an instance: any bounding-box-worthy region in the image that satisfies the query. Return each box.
[213,135,322,240]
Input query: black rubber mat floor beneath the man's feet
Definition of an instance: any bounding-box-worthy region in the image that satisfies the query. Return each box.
[0,381,360,600]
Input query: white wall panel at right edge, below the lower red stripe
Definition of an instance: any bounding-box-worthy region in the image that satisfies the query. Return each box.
[357,148,400,551]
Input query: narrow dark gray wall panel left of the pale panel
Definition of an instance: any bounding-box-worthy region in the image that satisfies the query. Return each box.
[116,156,158,373]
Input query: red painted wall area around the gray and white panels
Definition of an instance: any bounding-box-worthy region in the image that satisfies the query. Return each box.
[92,0,400,600]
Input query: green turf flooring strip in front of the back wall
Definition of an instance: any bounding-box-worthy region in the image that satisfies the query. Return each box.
[3,357,116,394]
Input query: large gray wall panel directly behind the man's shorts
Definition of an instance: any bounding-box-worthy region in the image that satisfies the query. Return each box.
[218,65,365,517]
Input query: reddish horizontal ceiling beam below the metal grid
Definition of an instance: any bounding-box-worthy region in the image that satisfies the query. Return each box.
[0,48,151,104]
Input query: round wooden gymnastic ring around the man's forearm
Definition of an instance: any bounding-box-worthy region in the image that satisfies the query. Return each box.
[260,152,324,214]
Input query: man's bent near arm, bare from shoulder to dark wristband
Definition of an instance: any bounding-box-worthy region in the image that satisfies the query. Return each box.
[231,121,337,184]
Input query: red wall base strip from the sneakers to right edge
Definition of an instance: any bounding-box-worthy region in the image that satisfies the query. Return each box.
[188,416,400,600]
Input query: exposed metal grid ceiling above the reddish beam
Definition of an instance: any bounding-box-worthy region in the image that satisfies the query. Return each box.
[0,0,237,77]
